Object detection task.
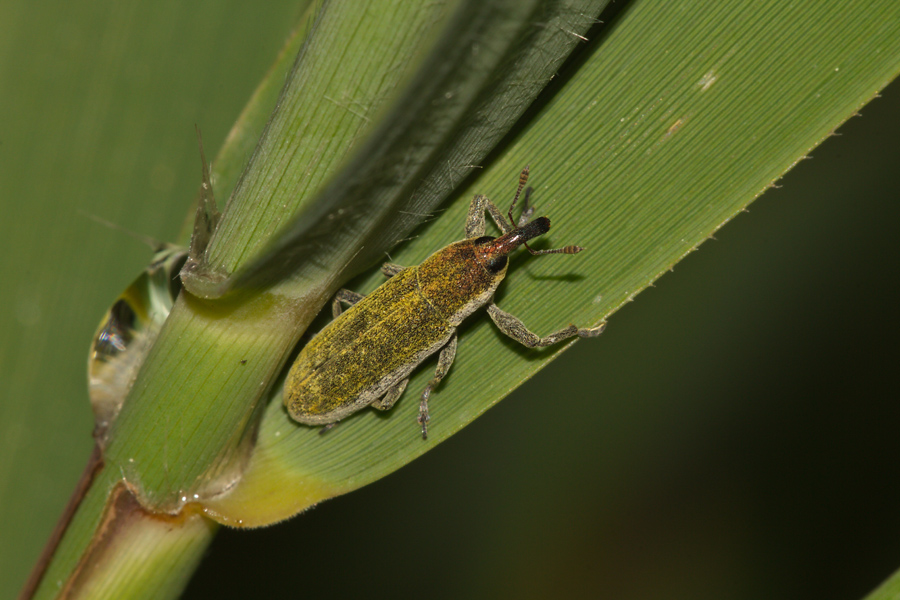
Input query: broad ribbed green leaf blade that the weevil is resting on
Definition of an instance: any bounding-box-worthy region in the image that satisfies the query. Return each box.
[204,2,900,524]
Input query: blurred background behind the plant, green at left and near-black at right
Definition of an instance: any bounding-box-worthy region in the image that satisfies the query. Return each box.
[0,0,900,599]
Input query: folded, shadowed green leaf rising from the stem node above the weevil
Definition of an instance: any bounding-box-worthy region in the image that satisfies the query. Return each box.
[186,0,604,296]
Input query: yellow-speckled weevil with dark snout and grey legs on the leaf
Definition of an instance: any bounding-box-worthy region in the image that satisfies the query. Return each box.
[284,167,604,438]
